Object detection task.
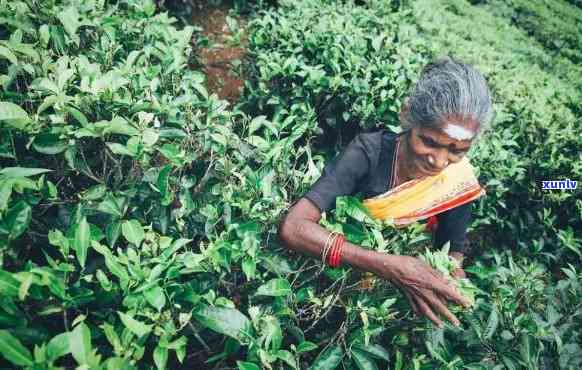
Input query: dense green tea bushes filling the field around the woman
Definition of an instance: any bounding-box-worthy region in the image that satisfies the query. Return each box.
[0,0,582,370]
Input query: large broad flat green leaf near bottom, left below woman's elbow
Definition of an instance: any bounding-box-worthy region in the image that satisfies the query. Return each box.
[194,306,250,339]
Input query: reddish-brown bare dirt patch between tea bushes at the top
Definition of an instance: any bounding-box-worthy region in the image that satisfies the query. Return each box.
[192,1,246,104]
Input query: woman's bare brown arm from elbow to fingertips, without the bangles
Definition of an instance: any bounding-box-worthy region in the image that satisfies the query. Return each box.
[279,198,469,326]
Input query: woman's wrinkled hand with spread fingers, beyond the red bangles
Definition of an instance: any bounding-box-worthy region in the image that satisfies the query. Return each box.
[373,254,470,327]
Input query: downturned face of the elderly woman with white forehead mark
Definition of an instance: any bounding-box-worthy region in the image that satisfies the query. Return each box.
[408,119,479,176]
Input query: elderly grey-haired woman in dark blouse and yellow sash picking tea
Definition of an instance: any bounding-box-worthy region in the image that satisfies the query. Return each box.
[279,57,492,326]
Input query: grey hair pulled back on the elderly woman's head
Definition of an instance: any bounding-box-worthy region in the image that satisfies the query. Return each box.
[402,57,493,132]
